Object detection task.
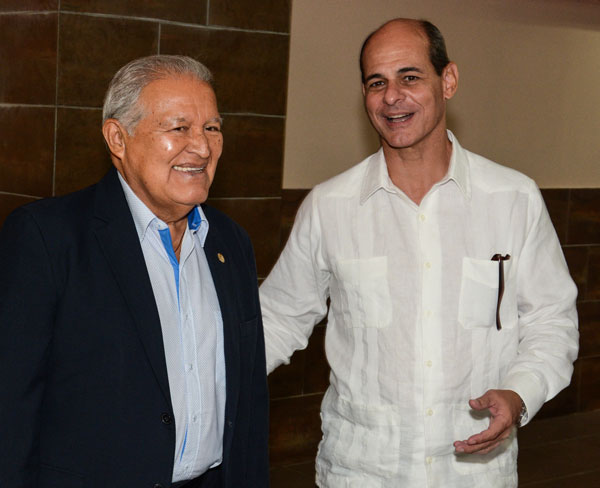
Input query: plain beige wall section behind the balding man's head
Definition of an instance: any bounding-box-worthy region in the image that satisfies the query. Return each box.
[283,0,600,188]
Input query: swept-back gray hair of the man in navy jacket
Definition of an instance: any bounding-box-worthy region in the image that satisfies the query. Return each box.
[102,54,213,133]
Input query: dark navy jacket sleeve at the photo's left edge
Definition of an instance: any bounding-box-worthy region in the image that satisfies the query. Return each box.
[0,209,57,488]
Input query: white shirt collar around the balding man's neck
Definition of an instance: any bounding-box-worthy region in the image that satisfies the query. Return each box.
[360,130,471,205]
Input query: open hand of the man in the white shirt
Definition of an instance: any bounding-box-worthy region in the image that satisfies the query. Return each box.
[454,390,521,454]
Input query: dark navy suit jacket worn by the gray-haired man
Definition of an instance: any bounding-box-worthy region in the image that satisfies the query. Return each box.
[0,169,269,488]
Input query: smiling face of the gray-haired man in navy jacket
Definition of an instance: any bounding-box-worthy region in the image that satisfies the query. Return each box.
[115,76,223,222]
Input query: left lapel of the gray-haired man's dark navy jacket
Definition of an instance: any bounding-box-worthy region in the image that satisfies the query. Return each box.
[94,169,171,405]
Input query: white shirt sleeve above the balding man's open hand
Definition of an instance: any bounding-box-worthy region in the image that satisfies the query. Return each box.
[502,183,579,423]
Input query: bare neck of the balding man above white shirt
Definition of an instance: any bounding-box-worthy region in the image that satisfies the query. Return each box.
[383,133,452,205]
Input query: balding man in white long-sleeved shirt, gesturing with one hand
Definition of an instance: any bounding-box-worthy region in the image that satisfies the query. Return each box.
[261,19,578,488]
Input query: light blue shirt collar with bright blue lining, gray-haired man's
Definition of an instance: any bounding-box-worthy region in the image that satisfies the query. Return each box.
[117,172,208,247]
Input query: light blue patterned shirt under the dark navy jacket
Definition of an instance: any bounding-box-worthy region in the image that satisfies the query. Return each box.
[119,174,225,482]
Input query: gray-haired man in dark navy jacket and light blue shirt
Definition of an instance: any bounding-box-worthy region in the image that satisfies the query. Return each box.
[0,56,268,488]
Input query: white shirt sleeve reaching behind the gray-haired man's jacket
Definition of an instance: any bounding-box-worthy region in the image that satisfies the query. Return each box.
[260,191,330,373]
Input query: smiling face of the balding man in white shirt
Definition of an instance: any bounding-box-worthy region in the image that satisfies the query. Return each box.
[363,21,458,151]
